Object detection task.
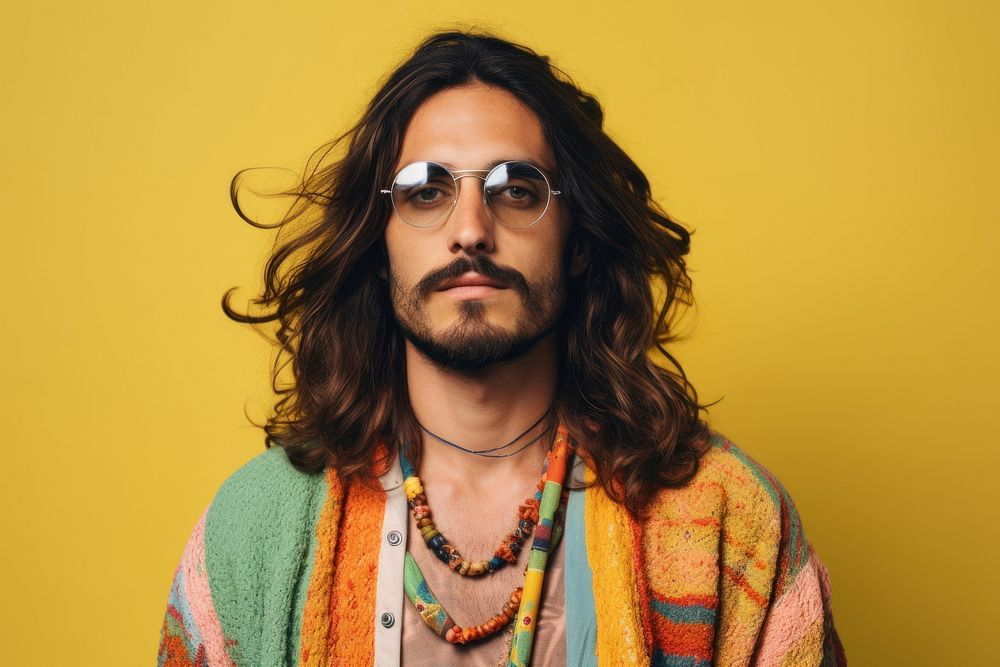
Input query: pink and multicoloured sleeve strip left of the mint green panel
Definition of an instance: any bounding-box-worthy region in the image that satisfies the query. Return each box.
[157,512,233,667]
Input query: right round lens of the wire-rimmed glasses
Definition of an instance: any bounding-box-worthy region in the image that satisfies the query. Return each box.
[485,162,549,227]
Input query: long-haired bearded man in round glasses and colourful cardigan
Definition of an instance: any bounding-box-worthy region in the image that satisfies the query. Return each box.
[160,32,843,665]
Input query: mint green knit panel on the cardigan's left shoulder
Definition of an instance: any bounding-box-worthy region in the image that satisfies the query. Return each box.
[205,447,327,667]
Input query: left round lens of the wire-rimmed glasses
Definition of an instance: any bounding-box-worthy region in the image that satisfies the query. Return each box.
[392,162,455,227]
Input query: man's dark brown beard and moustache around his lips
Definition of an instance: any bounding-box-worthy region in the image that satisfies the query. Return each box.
[389,255,566,372]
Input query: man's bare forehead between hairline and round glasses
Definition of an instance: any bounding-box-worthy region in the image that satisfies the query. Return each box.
[396,82,556,172]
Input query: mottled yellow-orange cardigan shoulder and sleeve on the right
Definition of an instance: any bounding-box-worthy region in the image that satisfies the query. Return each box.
[642,431,842,665]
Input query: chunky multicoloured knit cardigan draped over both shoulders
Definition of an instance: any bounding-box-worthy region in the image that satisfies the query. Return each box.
[159,434,846,667]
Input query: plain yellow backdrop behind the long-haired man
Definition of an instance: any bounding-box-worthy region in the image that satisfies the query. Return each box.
[0,0,1000,665]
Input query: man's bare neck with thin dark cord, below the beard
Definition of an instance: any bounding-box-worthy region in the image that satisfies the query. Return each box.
[406,334,557,483]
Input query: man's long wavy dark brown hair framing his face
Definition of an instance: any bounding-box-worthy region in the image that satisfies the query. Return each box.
[222,31,709,514]
